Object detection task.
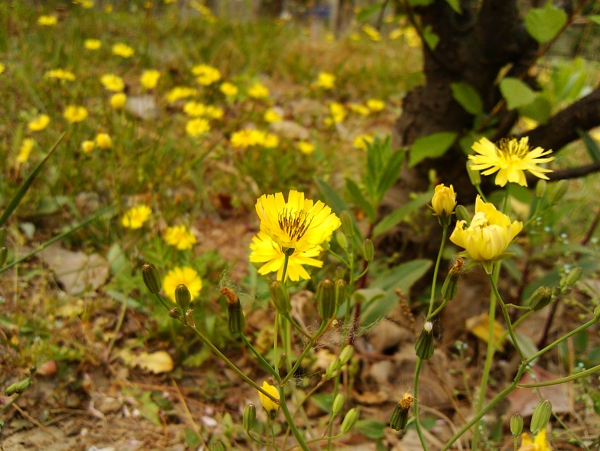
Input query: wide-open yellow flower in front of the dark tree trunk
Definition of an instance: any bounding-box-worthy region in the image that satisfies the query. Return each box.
[469,137,554,186]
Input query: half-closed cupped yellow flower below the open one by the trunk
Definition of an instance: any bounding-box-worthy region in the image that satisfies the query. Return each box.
[450,196,523,271]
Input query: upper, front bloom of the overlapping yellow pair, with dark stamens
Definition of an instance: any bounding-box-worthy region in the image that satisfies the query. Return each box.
[256,190,342,251]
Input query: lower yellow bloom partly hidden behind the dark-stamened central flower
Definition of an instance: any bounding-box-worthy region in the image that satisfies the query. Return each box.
[250,232,323,282]
